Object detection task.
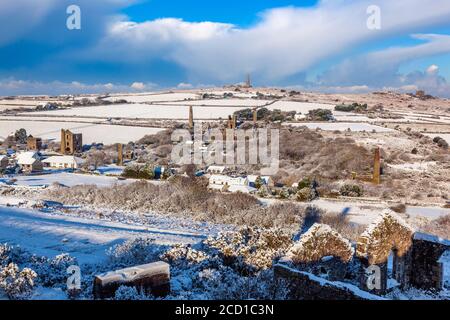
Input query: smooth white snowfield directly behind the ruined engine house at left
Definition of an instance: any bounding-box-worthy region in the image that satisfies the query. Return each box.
[0,120,163,144]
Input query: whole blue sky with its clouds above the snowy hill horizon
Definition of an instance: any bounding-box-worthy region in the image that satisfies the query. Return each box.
[0,0,450,97]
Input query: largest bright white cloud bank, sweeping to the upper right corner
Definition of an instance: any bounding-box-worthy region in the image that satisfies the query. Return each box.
[84,0,450,81]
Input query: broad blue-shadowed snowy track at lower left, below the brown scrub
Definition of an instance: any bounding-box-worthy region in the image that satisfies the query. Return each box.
[0,206,208,263]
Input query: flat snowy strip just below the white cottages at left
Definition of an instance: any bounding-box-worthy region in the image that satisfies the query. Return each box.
[0,172,135,187]
